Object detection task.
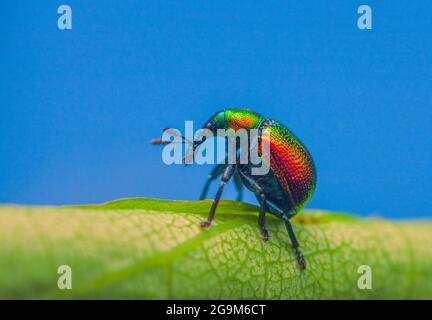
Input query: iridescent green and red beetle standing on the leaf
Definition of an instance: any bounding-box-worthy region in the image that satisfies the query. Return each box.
[151,109,316,269]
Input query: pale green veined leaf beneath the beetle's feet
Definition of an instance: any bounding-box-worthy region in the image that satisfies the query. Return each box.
[0,199,432,299]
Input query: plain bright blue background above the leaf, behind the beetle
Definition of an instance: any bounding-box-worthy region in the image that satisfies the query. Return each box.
[0,0,432,217]
